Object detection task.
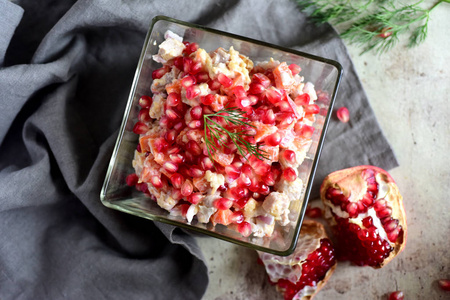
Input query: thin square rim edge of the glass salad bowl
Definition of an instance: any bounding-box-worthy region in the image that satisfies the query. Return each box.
[100,15,343,256]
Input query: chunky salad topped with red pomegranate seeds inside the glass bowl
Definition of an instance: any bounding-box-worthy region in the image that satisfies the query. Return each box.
[127,31,319,237]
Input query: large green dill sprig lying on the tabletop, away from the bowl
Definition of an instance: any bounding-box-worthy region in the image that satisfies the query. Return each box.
[296,0,450,54]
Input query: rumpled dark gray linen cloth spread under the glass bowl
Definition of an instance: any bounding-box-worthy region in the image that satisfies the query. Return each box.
[0,0,397,300]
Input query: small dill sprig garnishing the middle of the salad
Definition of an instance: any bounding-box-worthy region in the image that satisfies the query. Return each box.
[203,107,269,160]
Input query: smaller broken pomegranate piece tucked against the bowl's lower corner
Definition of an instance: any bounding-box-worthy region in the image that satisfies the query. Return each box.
[258,220,336,300]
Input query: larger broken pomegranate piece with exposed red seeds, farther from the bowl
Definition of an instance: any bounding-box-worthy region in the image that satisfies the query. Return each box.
[320,166,406,268]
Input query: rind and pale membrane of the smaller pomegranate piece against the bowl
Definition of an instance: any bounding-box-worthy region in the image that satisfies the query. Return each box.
[258,220,337,300]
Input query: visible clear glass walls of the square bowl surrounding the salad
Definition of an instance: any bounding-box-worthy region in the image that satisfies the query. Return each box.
[100,16,342,256]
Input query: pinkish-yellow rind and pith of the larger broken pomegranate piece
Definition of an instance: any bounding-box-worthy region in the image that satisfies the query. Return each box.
[320,165,407,269]
